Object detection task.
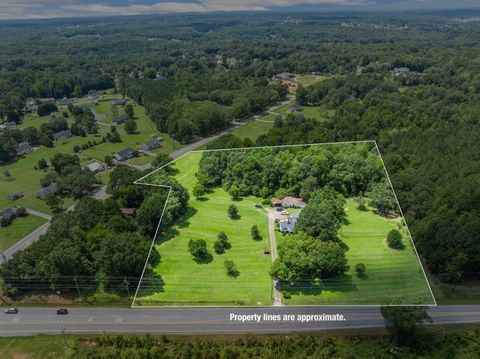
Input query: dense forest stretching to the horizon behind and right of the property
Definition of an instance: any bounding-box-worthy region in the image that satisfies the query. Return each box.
[0,12,480,292]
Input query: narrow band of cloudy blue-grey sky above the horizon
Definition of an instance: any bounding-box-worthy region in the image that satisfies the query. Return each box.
[0,0,480,20]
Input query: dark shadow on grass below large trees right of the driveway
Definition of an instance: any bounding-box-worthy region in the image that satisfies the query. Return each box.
[281,274,358,299]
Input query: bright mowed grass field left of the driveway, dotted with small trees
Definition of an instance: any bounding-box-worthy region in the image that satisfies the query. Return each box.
[135,152,272,305]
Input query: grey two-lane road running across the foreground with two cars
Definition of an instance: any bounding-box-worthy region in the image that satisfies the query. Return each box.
[0,305,480,336]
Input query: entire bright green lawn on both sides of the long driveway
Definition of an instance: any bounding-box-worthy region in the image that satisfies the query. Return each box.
[136,151,433,305]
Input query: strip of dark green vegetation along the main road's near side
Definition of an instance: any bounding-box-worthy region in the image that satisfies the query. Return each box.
[35,328,480,359]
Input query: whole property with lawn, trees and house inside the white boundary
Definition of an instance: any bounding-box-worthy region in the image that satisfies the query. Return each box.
[134,142,434,306]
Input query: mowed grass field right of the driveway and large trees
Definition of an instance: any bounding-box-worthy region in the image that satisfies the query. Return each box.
[277,199,434,305]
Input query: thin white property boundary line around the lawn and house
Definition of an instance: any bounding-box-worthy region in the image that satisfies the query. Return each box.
[131,140,437,309]
